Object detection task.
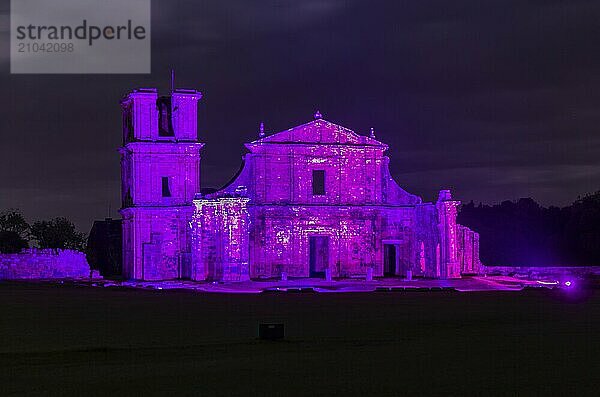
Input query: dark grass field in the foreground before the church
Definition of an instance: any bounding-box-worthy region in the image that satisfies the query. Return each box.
[0,283,600,396]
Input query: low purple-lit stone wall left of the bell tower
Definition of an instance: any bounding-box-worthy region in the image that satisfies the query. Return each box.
[0,248,90,280]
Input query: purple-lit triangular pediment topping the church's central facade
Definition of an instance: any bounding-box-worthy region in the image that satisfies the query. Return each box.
[251,119,387,148]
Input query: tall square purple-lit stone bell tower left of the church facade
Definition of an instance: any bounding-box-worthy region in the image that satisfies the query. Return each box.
[119,88,204,280]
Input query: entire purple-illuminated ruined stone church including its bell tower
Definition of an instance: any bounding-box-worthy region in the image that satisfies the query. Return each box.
[121,89,480,281]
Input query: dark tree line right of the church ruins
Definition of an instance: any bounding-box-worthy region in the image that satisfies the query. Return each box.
[458,191,600,266]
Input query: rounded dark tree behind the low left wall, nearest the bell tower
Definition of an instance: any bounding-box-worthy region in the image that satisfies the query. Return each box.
[31,217,86,251]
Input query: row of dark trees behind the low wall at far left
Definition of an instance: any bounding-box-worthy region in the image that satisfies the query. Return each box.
[0,209,87,254]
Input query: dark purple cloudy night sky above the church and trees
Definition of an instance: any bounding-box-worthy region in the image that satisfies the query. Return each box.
[0,0,600,231]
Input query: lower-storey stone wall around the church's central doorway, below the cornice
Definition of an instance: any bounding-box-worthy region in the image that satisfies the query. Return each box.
[250,206,384,277]
